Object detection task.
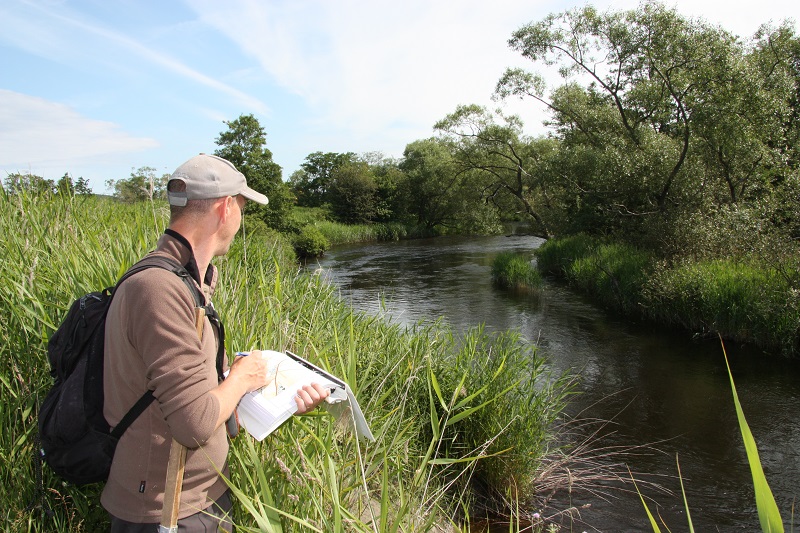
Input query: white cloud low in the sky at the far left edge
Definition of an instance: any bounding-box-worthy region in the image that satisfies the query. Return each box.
[0,89,158,173]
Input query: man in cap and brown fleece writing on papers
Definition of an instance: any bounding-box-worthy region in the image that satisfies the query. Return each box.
[101,154,329,532]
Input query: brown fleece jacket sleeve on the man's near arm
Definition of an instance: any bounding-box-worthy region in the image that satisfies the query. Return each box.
[126,268,220,448]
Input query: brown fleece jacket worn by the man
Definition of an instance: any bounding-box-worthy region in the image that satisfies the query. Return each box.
[100,234,228,523]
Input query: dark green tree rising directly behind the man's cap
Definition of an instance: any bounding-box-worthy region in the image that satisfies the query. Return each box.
[214,114,294,229]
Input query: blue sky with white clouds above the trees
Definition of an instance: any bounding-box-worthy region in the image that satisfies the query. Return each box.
[0,0,800,193]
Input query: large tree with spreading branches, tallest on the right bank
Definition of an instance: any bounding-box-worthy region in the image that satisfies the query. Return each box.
[497,1,791,241]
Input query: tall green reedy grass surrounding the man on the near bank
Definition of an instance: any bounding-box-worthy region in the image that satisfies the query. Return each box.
[0,194,569,532]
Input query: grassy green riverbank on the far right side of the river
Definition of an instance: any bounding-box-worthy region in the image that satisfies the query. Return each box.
[536,235,800,357]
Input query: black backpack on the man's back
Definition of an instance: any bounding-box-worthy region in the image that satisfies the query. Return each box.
[39,255,216,485]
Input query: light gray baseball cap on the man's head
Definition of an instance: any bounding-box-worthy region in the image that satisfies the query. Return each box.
[167,154,269,206]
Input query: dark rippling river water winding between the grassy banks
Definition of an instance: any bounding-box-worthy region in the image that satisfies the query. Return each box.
[308,236,800,532]
